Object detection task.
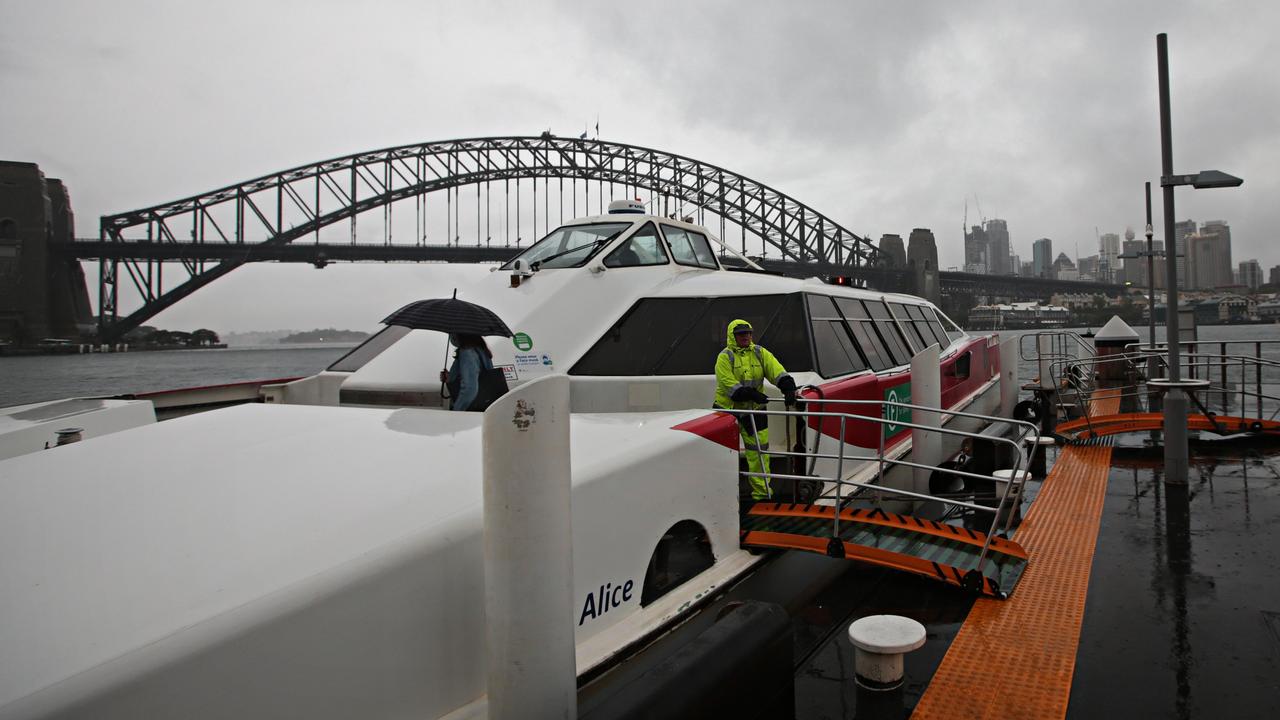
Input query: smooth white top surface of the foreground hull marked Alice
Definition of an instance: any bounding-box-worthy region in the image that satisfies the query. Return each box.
[0,404,707,715]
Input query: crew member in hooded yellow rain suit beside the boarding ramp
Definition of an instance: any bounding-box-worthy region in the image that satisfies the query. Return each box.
[716,320,796,500]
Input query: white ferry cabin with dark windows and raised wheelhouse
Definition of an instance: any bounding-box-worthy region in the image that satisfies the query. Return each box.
[275,201,993,413]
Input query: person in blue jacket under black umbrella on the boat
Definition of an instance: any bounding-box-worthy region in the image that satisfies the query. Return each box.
[383,290,512,411]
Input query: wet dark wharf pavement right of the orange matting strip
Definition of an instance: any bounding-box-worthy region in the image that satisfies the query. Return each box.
[1068,438,1280,719]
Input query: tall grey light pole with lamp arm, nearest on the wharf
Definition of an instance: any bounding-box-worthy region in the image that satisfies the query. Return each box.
[1156,33,1244,484]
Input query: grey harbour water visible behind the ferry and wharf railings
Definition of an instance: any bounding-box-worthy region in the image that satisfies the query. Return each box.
[0,320,1280,407]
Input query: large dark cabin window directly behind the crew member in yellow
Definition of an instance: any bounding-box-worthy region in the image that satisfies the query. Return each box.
[655,295,813,375]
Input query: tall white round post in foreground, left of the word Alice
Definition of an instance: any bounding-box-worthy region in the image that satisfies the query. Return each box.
[483,374,577,720]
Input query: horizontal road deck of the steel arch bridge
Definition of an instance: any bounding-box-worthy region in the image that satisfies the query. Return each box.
[56,238,1124,302]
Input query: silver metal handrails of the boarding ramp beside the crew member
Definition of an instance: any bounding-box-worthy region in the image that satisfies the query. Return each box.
[726,397,1039,589]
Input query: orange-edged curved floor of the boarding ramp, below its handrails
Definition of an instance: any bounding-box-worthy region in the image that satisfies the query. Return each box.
[741,502,1027,598]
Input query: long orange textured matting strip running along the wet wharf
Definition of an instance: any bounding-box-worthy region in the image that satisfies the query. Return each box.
[911,435,1119,720]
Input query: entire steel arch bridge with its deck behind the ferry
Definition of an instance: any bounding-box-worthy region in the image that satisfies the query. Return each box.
[22,133,1121,342]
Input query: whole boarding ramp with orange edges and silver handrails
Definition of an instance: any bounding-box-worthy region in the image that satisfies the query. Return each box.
[741,400,1038,598]
